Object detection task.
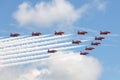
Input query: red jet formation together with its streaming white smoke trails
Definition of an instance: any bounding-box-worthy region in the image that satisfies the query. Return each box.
[0,31,110,67]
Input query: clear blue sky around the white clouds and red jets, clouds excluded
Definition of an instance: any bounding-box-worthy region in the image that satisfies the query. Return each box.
[0,0,120,80]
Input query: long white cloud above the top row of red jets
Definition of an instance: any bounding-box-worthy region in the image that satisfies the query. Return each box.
[13,0,89,26]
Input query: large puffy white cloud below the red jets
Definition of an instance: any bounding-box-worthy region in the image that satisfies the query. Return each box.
[17,52,101,80]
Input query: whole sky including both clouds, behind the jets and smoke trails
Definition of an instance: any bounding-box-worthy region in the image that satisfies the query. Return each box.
[0,0,120,80]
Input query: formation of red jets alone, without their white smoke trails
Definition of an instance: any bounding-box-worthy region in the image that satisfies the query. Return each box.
[10,31,110,55]
